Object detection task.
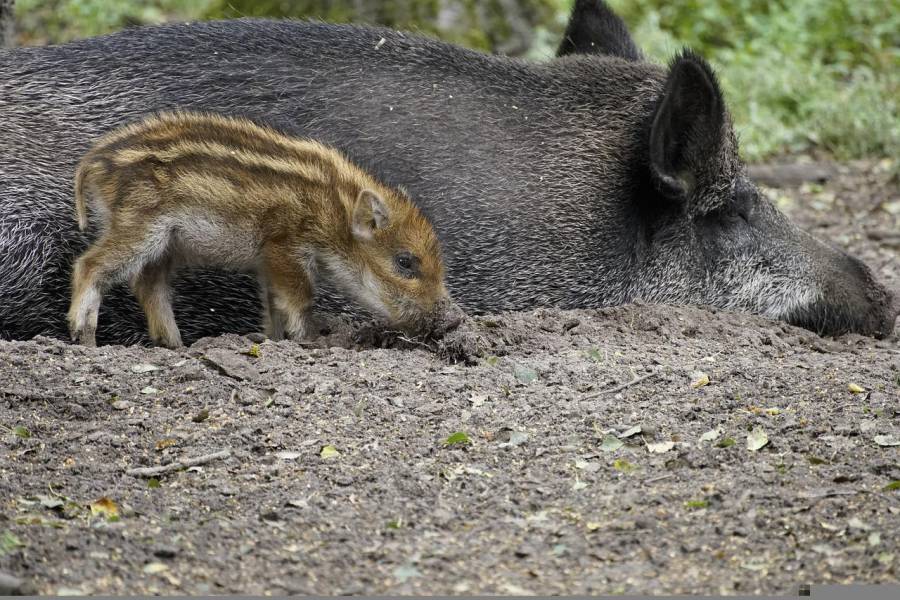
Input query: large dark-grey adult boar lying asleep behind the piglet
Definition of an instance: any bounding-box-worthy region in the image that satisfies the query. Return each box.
[0,2,898,343]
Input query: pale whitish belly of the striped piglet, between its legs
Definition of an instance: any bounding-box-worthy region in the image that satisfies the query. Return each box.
[170,216,263,271]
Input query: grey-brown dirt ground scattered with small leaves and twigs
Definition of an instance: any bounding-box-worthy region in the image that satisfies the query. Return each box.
[0,163,900,595]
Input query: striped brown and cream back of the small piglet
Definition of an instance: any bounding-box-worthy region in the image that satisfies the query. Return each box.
[75,113,378,220]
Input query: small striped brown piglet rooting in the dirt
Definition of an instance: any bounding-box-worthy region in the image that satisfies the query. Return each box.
[69,113,452,347]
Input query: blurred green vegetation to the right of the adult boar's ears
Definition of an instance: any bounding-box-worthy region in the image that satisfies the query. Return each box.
[609,0,900,160]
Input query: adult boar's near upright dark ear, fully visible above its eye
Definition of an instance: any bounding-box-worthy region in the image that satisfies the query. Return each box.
[650,51,725,197]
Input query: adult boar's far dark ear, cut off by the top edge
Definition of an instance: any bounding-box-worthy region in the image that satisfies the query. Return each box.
[556,0,641,60]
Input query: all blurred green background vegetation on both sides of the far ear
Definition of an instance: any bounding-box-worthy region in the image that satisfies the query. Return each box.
[10,0,900,160]
